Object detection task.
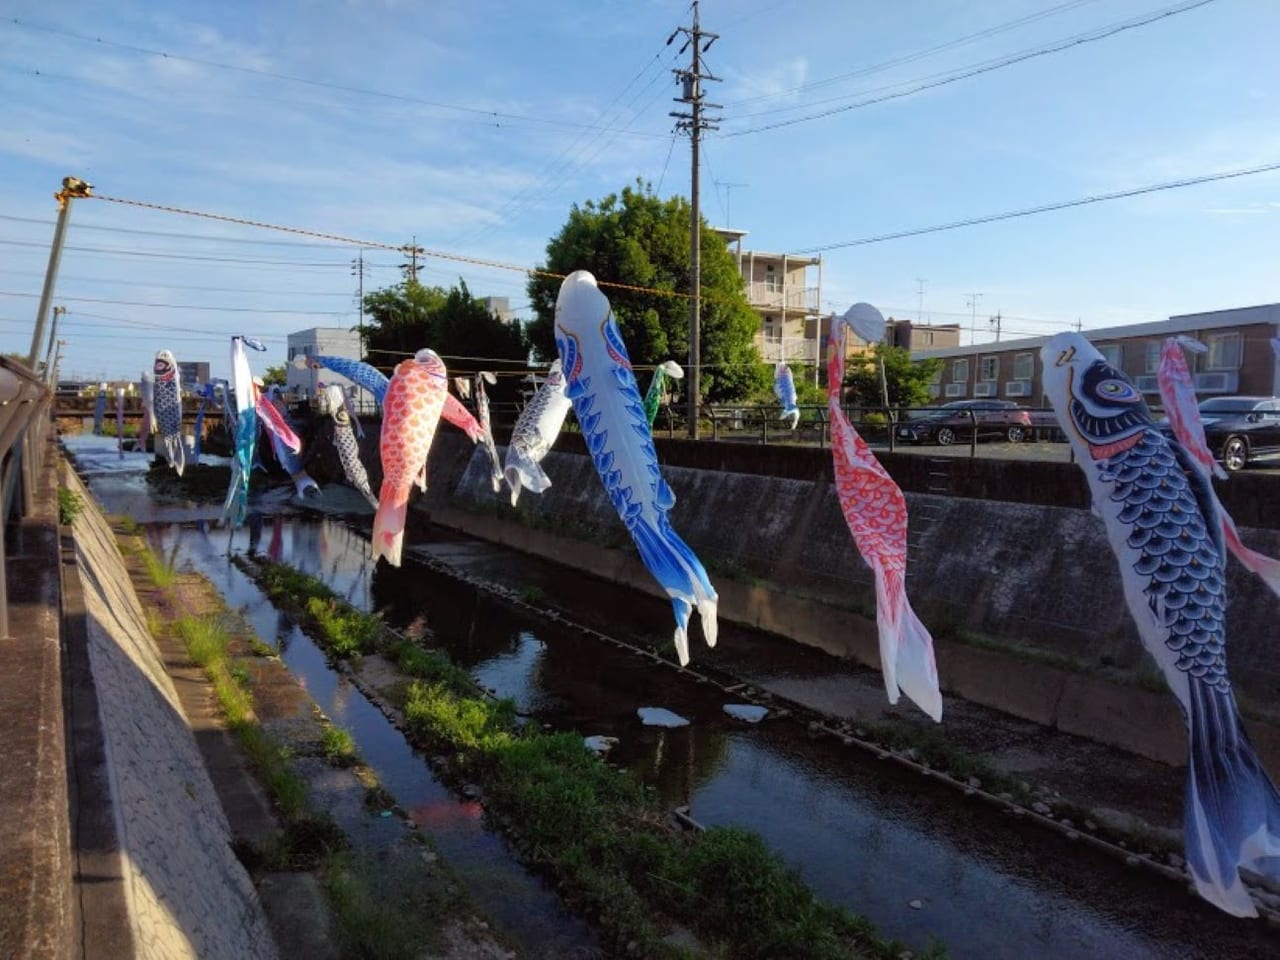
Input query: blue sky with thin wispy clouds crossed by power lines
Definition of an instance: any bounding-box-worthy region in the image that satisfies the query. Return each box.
[0,0,1280,378]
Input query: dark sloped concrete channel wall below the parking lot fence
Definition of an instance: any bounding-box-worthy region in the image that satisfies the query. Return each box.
[419,434,1280,767]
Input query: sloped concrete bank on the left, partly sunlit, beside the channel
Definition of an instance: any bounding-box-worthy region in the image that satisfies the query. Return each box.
[65,470,276,960]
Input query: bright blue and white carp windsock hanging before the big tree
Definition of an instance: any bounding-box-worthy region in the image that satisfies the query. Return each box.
[556,270,719,666]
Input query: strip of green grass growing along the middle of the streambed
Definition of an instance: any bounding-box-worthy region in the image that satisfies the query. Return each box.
[235,563,901,960]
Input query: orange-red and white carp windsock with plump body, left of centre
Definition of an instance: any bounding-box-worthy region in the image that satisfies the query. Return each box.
[371,349,449,567]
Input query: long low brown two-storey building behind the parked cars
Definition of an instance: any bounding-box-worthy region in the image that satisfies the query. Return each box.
[911,303,1280,406]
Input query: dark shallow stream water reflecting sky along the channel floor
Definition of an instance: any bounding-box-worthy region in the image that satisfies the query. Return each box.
[64,437,1280,957]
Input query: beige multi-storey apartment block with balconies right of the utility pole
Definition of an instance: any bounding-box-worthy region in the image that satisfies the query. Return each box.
[716,227,822,365]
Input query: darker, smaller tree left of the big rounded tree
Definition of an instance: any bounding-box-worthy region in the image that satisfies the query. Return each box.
[365,279,529,396]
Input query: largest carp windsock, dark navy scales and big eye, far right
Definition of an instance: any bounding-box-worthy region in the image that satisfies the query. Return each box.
[1041,333,1280,916]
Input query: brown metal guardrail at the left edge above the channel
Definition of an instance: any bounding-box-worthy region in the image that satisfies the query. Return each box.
[0,357,52,636]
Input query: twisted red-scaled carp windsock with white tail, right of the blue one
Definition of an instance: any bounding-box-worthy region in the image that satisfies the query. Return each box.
[827,303,942,721]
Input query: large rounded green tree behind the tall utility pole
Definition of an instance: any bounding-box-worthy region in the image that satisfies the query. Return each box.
[527,180,769,402]
